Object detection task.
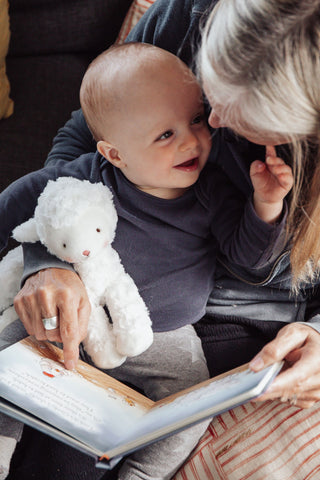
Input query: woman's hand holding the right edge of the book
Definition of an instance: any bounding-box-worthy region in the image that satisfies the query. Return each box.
[250,323,320,408]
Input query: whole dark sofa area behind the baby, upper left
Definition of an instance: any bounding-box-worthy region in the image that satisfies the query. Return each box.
[0,0,132,191]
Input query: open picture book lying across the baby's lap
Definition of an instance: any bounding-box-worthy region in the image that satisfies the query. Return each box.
[0,337,281,468]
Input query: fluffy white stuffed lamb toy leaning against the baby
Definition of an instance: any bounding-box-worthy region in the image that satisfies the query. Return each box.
[0,177,153,368]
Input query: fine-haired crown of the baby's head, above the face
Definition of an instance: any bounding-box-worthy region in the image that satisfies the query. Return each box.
[80,43,197,141]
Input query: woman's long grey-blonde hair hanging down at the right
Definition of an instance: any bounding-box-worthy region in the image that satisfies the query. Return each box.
[198,0,320,288]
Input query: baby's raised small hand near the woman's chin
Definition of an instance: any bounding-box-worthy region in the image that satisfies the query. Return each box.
[250,146,293,223]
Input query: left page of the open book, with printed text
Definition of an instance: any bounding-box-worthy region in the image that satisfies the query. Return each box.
[0,337,153,454]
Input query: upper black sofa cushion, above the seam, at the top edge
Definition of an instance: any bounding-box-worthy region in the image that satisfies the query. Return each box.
[9,0,132,56]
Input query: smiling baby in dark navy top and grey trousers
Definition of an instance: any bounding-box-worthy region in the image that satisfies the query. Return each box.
[0,43,292,480]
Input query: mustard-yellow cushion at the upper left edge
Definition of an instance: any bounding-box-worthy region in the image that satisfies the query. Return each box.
[0,0,13,119]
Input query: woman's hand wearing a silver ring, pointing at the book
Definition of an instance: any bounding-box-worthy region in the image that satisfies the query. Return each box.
[14,268,90,370]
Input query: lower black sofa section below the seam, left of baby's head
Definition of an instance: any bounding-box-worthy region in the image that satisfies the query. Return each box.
[0,54,90,190]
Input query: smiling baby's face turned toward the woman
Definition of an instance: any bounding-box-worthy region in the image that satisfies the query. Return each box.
[108,61,211,198]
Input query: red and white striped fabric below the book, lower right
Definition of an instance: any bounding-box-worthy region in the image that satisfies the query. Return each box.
[173,401,320,480]
